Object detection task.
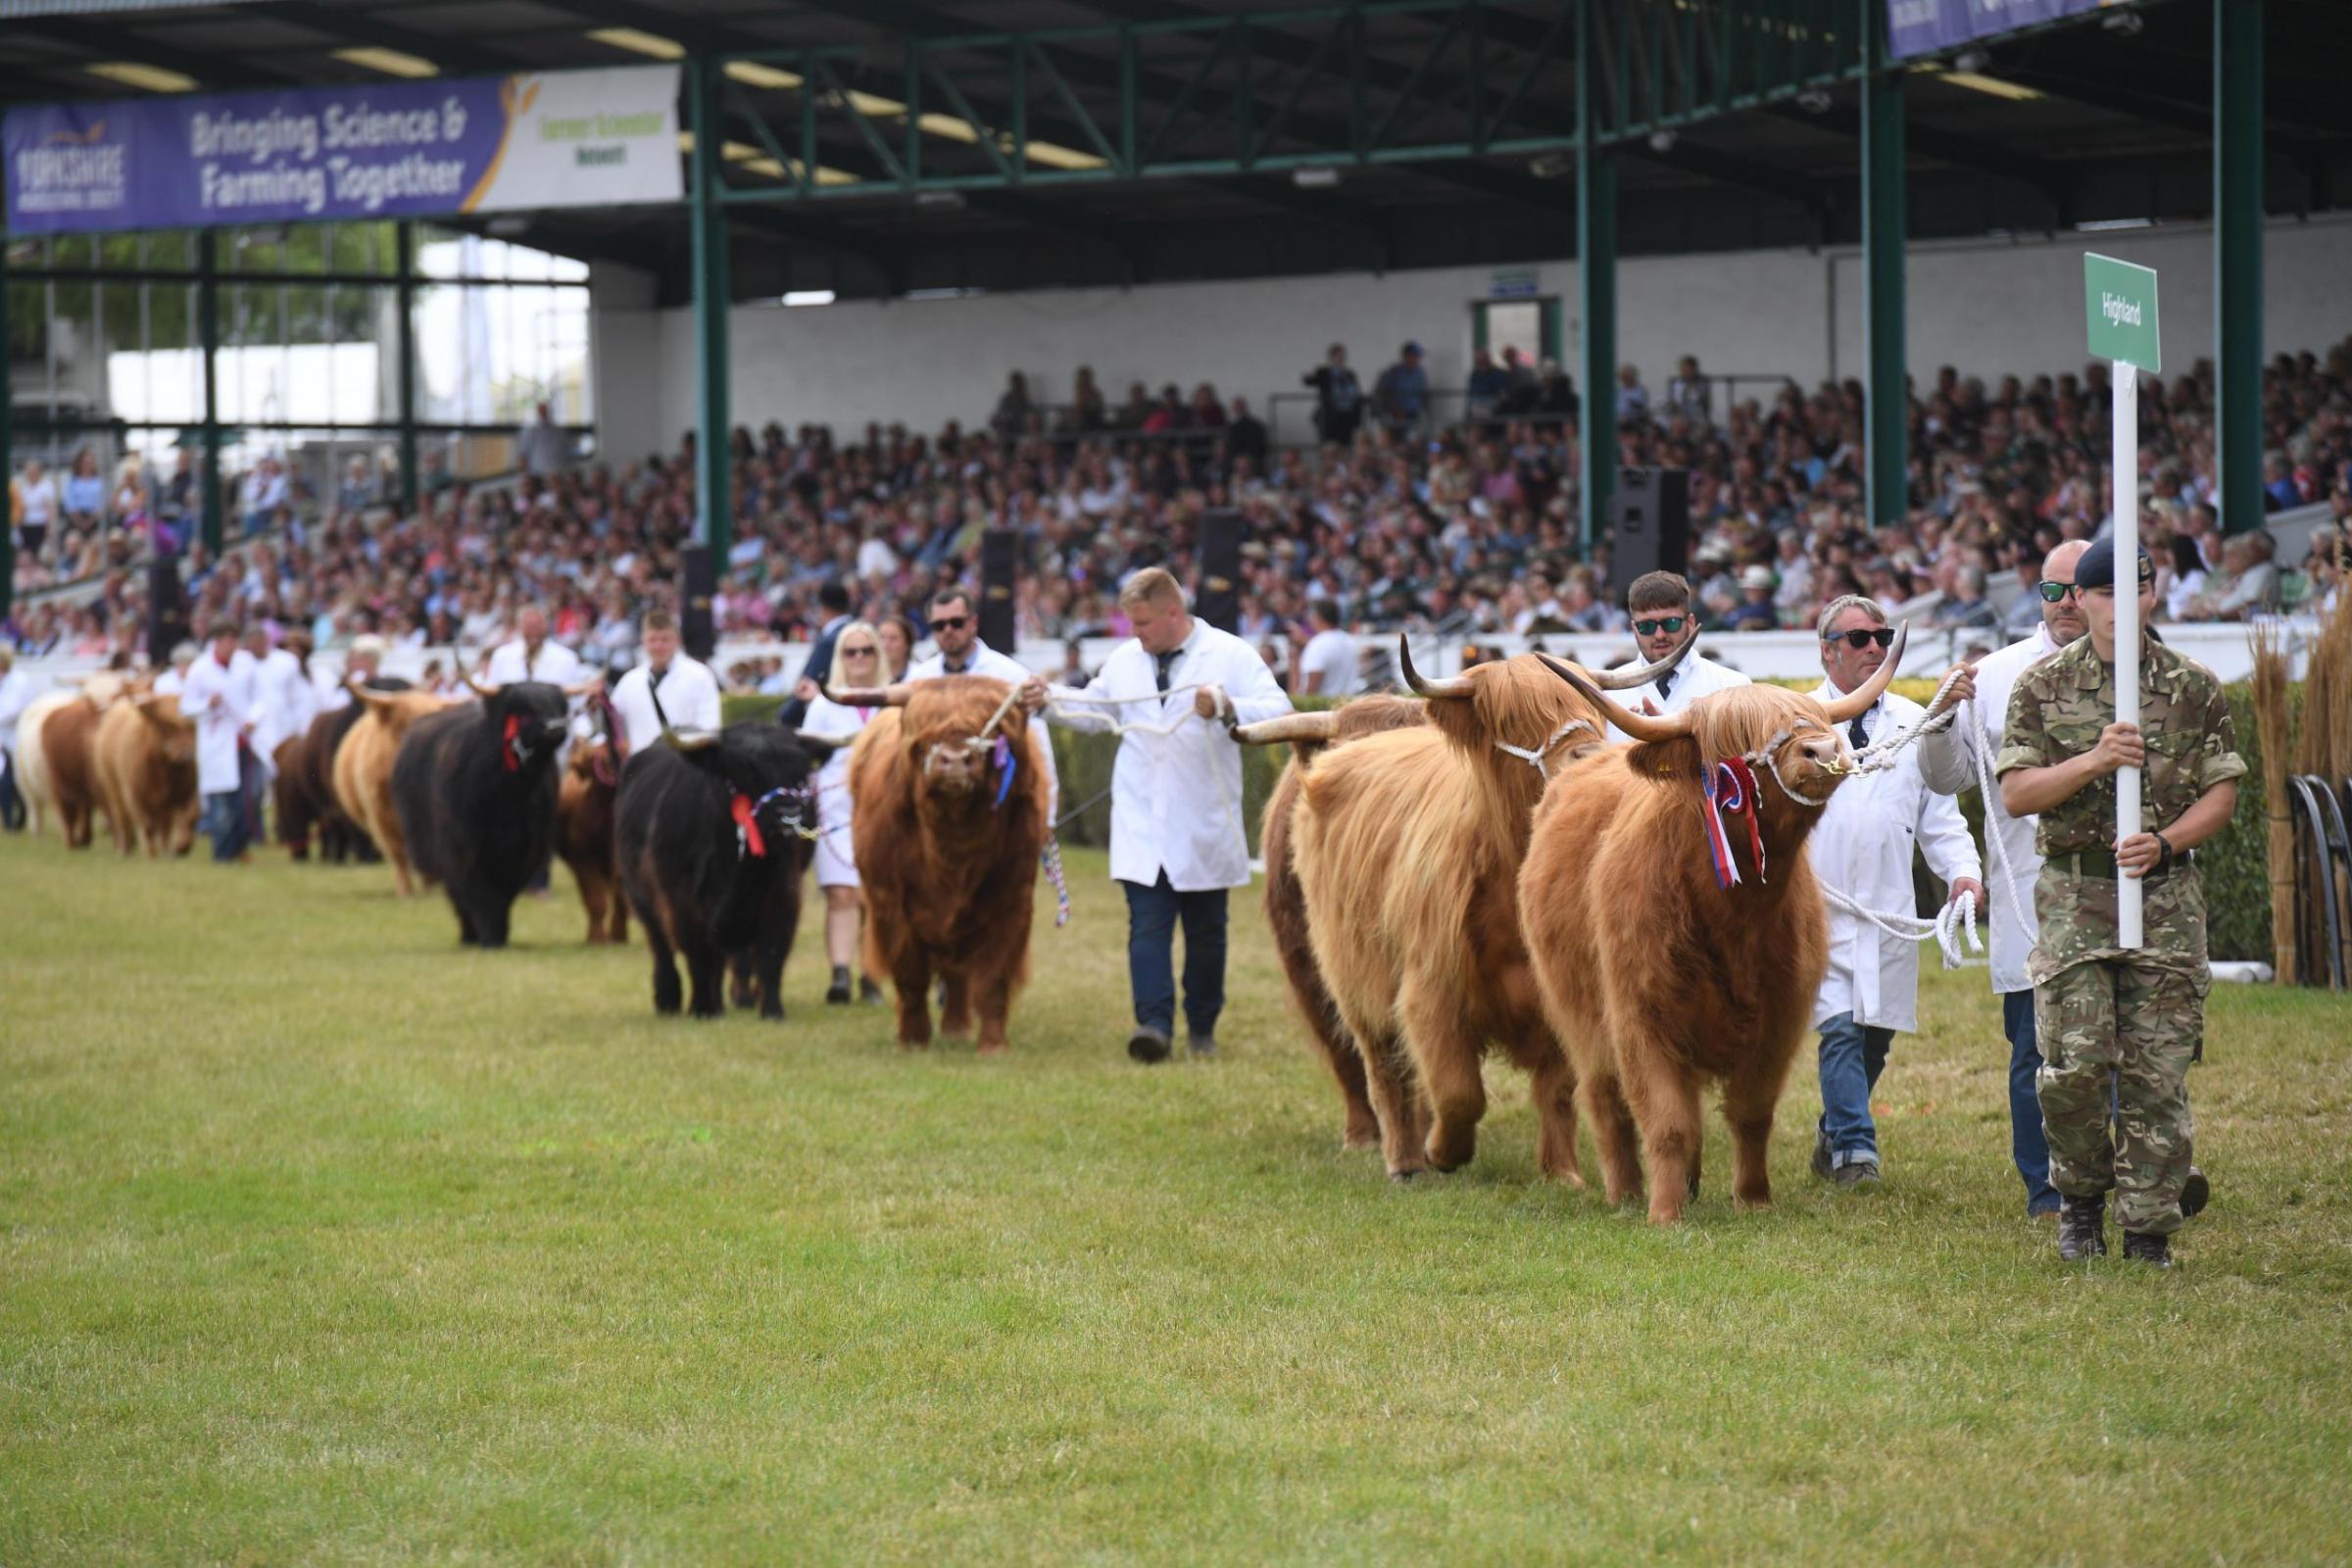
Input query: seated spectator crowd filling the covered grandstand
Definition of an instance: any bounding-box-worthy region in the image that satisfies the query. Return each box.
[18,328,2352,679]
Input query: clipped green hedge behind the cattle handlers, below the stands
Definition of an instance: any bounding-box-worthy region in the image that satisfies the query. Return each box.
[724,679,2303,964]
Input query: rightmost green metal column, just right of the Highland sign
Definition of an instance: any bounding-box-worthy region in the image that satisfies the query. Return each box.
[2213,0,2263,534]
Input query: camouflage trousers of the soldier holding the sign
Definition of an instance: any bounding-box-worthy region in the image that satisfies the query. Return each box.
[2034,950,2211,1234]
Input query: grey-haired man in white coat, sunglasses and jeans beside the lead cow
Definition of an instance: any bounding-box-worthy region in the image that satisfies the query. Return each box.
[1809,595,1985,1187]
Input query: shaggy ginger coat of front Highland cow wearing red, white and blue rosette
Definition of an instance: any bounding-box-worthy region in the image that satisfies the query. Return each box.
[1519,676,1893,1222]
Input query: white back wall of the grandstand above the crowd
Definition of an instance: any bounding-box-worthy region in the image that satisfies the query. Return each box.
[615,211,2352,454]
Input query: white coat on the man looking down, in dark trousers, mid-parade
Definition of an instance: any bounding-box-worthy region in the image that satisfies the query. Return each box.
[1054,618,1292,894]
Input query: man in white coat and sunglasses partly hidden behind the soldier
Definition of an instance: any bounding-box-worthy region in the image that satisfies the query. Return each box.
[1919,541,2091,1215]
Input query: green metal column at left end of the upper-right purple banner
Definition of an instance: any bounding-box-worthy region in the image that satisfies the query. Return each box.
[1863,0,1910,529]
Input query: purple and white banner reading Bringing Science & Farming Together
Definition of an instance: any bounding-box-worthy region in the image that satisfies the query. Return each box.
[0,66,682,235]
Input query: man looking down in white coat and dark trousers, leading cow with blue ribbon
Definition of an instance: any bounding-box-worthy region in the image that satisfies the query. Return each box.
[1030,566,1292,1062]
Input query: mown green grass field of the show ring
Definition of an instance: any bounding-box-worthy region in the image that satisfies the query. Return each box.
[0,837,2352,1568]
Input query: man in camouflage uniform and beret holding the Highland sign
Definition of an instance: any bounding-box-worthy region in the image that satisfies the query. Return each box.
[1994,541,2246,1267]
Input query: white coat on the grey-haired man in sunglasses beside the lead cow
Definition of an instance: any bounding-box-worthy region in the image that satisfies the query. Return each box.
[1806,682,1983,1032]
